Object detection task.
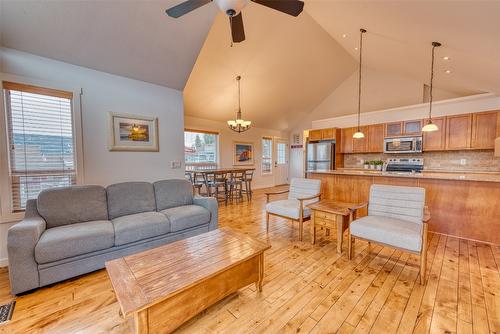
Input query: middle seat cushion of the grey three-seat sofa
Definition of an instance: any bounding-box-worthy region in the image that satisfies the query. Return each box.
[111,212,170,246]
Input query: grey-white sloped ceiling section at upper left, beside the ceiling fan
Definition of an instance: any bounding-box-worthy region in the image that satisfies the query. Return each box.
[0,0,217,90]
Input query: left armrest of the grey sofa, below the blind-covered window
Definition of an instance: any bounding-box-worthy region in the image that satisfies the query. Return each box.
[7,200,46,294]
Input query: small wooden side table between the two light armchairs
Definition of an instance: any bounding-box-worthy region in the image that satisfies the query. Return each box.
[307,199,366,253]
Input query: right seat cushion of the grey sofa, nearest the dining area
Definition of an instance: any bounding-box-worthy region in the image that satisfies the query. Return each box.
[161,205,210,232]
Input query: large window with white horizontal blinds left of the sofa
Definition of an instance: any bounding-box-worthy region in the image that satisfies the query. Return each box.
[3,82,76,212]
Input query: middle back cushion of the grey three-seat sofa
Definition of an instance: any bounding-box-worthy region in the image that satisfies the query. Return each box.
[106,182,156,219]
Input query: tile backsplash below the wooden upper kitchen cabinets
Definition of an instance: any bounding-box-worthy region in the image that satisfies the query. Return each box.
[344,150,500,172]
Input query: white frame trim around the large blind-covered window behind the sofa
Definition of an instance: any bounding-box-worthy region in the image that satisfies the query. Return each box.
[0,73,85,223]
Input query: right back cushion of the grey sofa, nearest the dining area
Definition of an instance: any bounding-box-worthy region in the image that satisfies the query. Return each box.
[153,180,193,211]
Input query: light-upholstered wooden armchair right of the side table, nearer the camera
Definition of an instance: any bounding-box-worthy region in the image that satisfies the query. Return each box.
[348,184,430,285]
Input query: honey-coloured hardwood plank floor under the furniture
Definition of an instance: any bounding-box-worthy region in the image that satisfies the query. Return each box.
[0,187,500,334]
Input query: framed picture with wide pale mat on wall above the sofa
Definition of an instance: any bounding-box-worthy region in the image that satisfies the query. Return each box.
[108,112,159,152]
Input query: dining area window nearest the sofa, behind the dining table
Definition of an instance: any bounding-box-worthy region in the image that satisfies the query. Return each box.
[184,129,219,169]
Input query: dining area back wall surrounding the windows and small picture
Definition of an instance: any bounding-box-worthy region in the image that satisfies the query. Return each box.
[185,116,288,189]
